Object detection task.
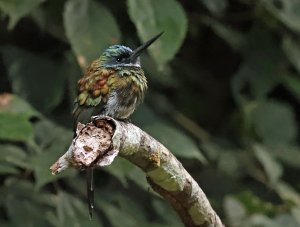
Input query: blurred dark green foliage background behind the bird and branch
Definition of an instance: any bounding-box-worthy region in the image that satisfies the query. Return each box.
[0,0,300,227]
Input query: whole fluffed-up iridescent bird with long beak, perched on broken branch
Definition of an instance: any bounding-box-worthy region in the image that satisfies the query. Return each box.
[72,32,163,219]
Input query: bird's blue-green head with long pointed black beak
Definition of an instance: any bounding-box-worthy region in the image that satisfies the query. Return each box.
[100,32,163,68]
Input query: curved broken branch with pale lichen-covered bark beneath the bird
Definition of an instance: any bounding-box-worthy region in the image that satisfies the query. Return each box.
[51,117,223,227]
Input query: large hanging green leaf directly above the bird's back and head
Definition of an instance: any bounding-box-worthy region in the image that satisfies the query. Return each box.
[63,0,121,67]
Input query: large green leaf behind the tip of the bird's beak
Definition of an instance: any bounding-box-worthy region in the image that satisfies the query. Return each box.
[127,0,187,66]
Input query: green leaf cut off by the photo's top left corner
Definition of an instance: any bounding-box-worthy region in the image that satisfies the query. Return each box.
[0,0,45,29]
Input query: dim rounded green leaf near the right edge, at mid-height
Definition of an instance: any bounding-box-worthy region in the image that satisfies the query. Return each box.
[253,101,298,145]
